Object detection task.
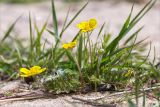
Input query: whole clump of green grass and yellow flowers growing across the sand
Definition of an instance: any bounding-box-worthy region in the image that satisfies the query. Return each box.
[0,0,160,103]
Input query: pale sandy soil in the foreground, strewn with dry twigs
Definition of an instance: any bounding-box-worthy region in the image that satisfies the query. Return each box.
[0,80,158,107]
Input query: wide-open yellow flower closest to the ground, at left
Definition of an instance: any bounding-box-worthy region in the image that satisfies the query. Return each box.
[20,66,46,77]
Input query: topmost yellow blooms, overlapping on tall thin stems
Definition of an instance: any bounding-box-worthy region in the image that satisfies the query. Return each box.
[77,18,97,32]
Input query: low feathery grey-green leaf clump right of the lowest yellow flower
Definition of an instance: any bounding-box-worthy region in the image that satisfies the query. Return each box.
[44,69,80,94]
